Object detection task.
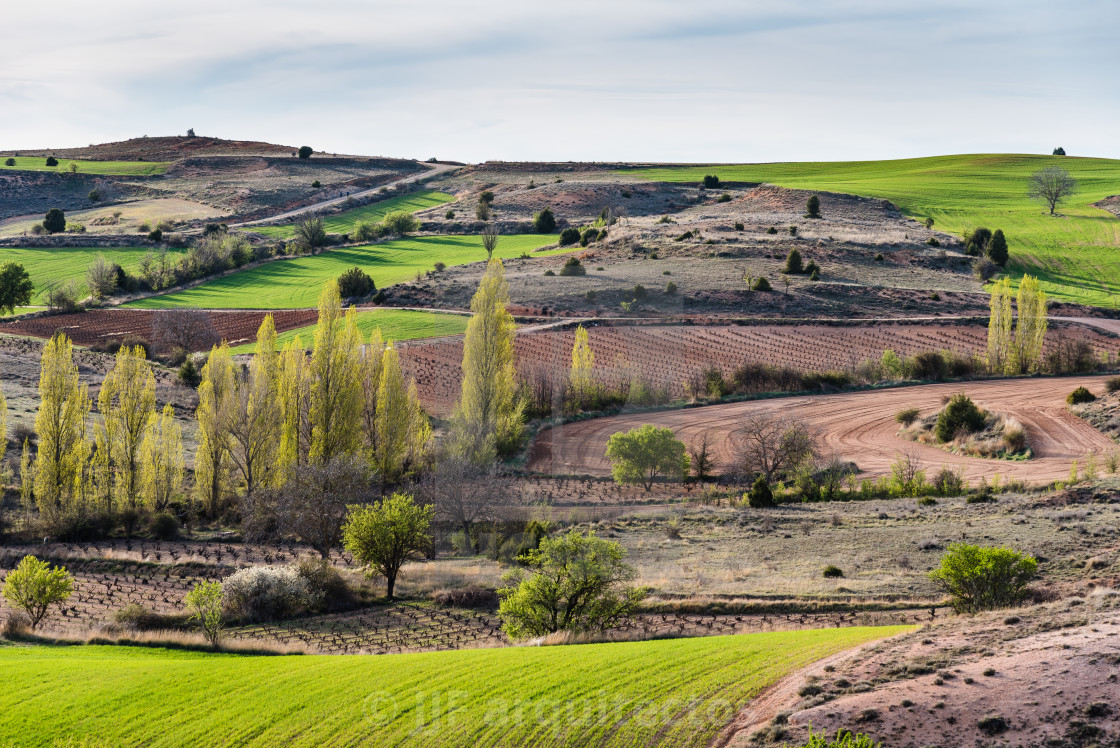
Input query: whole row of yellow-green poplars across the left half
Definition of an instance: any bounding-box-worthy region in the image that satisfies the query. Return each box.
[16,259,524,526]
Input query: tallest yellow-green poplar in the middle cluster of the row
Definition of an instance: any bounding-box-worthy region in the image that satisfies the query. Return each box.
[309,281,363,465]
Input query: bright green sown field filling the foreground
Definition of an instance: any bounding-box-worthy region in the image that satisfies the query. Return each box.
[0,627,909,748]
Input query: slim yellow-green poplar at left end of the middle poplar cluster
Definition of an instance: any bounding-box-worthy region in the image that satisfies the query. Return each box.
[195,342,234,517]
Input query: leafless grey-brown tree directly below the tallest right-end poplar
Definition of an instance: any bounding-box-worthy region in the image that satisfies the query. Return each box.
[419,456,522,552]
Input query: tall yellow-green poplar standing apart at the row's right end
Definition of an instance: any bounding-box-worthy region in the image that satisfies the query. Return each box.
[454,259,525,462]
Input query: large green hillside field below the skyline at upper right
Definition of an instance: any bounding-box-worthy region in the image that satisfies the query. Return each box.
[628,155,1120,307]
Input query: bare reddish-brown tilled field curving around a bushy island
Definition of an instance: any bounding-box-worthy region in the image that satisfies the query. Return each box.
[528,376,1116,484]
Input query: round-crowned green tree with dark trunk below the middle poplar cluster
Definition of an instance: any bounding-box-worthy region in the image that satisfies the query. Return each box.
[343,494,432,600]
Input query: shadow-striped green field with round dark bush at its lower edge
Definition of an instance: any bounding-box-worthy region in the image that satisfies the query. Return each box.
[129,234,560,309]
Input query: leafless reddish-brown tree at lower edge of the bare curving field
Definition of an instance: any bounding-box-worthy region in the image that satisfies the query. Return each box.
[731,413,818,483]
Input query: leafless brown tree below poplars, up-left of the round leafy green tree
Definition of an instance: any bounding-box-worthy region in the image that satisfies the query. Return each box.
[243,456,373,559]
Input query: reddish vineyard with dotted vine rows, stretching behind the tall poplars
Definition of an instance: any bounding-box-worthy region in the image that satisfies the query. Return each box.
[402,324,1120,414]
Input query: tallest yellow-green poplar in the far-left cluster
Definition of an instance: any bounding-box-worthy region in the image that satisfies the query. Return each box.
[35,333,91,516]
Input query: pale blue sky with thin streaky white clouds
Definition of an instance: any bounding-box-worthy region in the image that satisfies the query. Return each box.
[0,0,1120,162]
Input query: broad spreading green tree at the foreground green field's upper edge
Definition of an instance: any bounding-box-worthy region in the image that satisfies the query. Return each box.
[498,530,648,639]
